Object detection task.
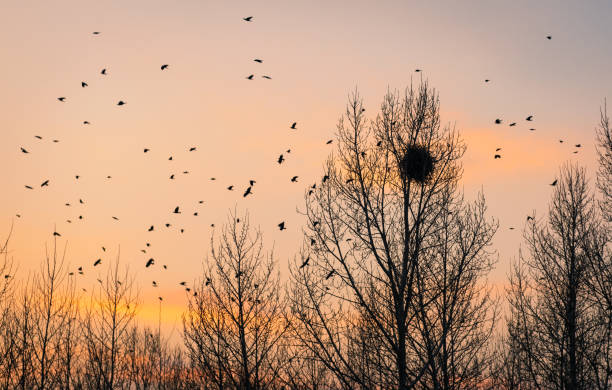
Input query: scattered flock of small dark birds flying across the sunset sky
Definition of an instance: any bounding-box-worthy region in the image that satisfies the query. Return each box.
[5,16,581,302]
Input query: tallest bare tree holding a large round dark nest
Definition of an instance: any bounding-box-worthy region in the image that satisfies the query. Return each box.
[291,82,496,390]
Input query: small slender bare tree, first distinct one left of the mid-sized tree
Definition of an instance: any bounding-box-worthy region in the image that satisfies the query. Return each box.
[82,256,138,390]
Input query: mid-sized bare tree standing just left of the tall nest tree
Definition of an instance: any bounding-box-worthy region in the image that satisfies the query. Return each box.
[183,212,287,390]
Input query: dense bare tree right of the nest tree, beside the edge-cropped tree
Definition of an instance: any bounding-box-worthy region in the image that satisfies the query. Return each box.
[508,165,612,390]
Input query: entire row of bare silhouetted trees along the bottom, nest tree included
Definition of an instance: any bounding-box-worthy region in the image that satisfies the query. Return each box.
[0,83,612,390]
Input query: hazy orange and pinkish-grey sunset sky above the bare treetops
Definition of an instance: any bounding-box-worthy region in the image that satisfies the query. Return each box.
[0,0,612,332]
